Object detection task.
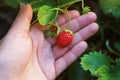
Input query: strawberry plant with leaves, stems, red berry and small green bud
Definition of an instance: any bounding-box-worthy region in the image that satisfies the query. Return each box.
[19,0,90,47]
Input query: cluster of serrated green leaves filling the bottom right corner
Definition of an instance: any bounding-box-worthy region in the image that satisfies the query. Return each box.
[80,52,120,80]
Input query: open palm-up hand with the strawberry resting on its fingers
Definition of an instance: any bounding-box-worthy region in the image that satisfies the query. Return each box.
[0,4,98,80]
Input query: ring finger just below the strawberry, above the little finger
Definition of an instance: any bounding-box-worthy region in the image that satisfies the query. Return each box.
[53,23,98,59]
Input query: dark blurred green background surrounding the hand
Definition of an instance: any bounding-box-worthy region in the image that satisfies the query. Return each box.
[0,0,120,80]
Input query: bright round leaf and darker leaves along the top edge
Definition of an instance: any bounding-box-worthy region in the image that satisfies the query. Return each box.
[19,0,80,26]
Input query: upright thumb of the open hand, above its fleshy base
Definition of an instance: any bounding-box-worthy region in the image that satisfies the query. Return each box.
[9,4,32,34]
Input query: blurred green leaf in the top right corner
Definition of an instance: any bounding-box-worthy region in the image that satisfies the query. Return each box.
[99,0,120,18]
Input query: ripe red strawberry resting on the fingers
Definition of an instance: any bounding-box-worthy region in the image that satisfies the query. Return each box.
[56,30,73,48]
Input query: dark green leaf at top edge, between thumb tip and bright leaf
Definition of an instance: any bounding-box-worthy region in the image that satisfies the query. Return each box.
[31,0,57,12]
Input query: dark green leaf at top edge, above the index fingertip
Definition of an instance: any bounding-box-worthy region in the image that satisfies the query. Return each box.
[57,0,81,8]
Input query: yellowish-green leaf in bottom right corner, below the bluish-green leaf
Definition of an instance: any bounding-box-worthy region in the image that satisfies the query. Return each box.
[97,58,120,80]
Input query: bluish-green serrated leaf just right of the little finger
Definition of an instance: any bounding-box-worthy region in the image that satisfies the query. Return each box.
[80,52,112,76]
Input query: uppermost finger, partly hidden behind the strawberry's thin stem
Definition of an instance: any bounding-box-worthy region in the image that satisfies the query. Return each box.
[56,10,80,25]
